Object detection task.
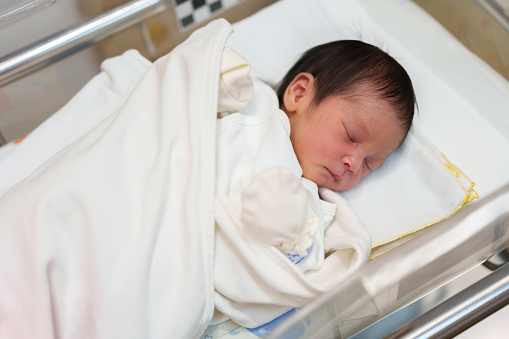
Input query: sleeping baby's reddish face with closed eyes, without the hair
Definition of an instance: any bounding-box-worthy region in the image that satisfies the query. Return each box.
[289,96,404,191]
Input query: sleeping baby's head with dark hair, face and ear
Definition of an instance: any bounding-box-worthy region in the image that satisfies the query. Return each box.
[277,40,415,191]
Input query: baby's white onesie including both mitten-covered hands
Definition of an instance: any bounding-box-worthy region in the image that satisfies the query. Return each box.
[216,48,336,270]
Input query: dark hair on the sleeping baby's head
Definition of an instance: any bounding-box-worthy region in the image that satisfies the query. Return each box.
[277,40,416,134]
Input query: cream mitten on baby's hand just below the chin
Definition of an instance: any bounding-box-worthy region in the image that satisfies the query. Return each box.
[241,168,318,256]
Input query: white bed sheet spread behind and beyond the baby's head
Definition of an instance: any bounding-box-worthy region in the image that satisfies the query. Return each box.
[228,0,509,202]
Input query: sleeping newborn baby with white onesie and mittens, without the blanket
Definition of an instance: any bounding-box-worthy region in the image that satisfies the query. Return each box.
[214,41,415,263]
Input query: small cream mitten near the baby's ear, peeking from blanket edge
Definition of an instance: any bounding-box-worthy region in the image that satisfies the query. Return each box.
[217,47,254,112]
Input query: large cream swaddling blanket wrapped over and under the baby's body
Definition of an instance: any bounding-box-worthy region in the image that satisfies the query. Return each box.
[0,20,370,338]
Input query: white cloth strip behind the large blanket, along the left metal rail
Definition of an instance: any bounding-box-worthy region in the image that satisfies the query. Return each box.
[0,50,151,196]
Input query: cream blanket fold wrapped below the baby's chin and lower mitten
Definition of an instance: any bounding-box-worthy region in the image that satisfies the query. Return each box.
[212,188,371,327]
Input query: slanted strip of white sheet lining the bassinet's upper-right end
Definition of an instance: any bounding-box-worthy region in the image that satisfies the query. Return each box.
[362,0,509,139]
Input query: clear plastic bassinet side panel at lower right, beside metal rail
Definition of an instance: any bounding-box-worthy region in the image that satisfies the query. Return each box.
[270,185,509,338]
